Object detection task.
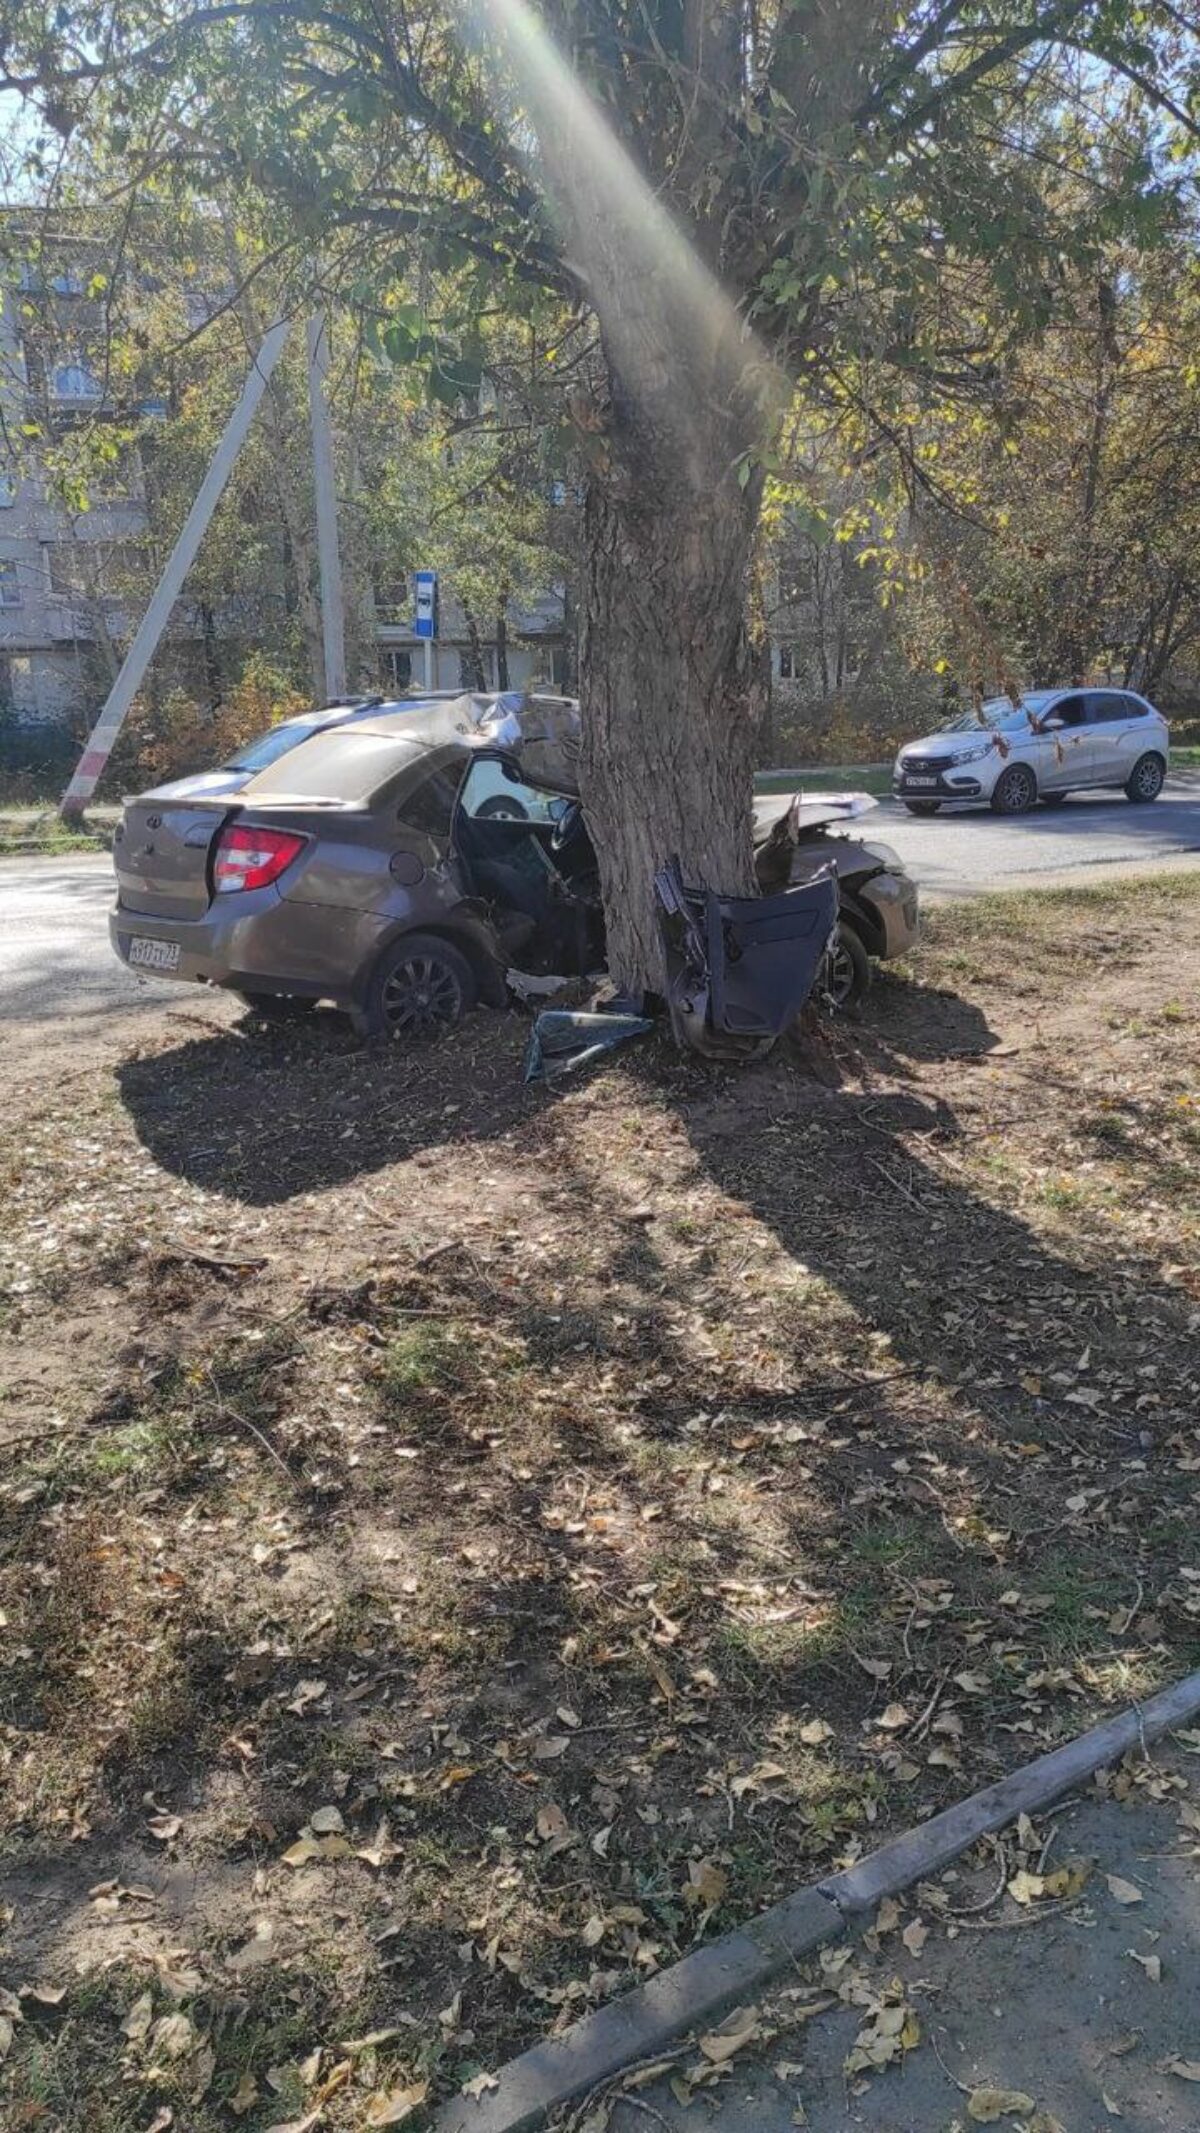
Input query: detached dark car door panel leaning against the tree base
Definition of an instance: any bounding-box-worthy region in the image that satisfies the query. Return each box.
[654,860,838,1058]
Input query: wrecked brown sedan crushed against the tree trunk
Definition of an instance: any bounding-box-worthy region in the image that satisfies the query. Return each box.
[109,695,917,1039]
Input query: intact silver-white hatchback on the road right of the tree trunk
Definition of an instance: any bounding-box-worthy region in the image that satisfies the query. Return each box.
[891,689,1170,815]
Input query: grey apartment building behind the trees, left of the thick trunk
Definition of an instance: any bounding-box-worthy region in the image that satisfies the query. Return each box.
[0,213,567,727]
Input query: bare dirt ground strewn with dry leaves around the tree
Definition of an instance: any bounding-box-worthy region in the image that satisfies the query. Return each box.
[0,875,1200,2133]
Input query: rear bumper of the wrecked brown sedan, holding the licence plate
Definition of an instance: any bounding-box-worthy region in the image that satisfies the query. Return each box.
[109,889,388,1007]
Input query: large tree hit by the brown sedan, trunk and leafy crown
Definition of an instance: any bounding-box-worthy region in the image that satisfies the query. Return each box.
[0,0,1198,981]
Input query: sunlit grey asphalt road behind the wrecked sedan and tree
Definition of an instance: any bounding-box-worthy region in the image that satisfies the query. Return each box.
[0,772,1200,1022]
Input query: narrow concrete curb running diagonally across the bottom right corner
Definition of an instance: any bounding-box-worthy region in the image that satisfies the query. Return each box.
[435,1672,1200,2133]
